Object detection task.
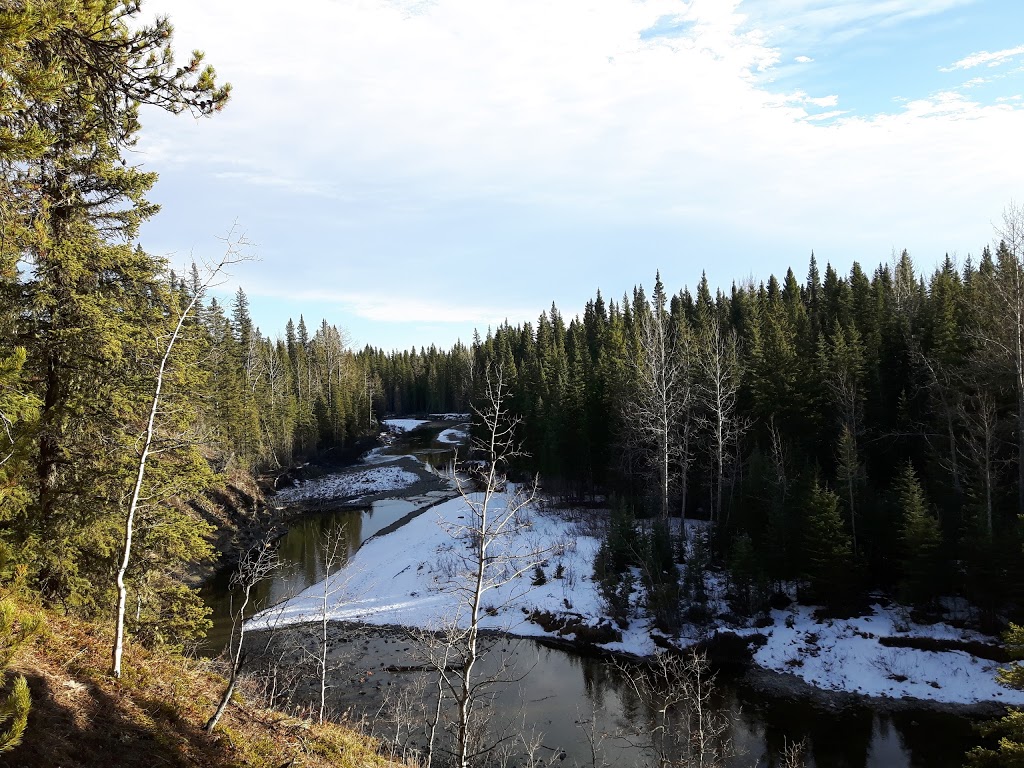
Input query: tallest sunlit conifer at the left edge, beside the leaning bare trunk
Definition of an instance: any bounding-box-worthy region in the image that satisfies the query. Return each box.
[0,0,227,609]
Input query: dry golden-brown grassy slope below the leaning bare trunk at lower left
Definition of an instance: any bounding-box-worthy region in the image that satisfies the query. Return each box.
[0,613,415,768]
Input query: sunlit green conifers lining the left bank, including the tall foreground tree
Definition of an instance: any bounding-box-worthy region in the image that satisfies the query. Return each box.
[0,0,469,679]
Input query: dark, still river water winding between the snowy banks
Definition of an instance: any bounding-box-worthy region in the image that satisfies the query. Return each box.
[204,429,991,768]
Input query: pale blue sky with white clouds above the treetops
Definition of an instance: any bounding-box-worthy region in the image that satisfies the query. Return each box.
[131,0,1024,350]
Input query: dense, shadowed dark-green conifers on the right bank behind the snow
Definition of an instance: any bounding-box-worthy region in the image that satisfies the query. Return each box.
[472,225,1024,626]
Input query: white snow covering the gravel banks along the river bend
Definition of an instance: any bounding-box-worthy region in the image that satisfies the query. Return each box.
[254,489,1024,706]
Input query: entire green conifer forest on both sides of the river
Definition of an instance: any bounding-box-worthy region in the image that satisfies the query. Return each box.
[0,0,1024,765]
